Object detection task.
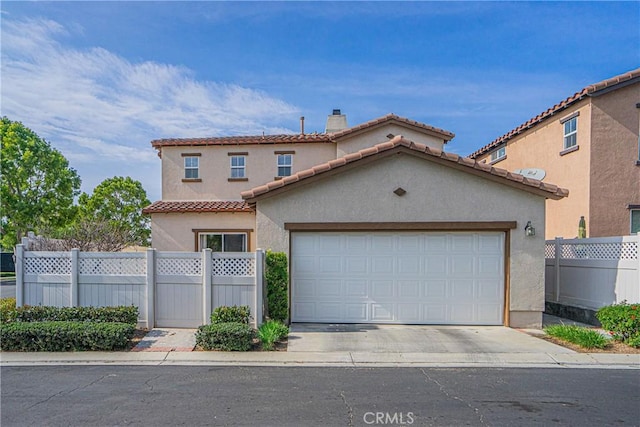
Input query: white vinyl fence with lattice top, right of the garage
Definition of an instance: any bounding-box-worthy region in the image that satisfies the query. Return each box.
[545,233,640,310]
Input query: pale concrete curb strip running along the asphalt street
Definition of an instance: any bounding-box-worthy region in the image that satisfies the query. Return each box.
[0,351,640,369]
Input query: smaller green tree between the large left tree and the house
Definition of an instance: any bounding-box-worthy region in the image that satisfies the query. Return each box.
[78,176,151,246]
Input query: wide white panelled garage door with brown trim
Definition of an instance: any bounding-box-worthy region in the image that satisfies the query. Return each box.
[291,232,505,325]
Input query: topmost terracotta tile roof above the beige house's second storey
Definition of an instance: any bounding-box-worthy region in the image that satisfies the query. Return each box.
[151,114,455,149]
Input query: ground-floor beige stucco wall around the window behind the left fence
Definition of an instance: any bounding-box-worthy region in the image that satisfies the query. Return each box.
[151,212,256,252]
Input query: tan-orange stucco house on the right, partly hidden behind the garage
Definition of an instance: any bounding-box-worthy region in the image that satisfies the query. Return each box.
[469,68,640,239]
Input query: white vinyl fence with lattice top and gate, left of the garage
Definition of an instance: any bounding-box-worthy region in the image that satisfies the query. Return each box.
[16,245,264,329]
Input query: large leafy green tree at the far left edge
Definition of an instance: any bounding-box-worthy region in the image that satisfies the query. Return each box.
[0,117,80,248]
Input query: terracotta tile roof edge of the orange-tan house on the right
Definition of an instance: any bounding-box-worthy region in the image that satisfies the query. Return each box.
[469,68,640,159]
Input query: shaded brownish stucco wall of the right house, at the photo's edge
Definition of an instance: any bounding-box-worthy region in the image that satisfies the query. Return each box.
[589,83,640,237]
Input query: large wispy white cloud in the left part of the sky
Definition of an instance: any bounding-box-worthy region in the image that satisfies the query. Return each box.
[1,17,297,198]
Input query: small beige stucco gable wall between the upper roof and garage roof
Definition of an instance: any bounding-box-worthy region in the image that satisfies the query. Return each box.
[337,123,444,157]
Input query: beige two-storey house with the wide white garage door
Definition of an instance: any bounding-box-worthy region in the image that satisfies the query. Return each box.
[145,111,567,327]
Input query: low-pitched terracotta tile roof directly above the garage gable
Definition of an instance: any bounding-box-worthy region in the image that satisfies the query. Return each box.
[240,135,569,203]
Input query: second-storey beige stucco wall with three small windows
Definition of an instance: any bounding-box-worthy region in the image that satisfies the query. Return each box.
[162,143,336,200]
